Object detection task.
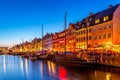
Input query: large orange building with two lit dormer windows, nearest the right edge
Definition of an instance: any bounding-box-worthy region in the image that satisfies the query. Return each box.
[92,5,120,49]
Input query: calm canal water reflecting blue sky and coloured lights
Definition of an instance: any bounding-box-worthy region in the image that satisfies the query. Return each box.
[0,55,120,80]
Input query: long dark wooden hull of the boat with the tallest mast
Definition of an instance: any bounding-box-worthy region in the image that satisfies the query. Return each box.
[55,55,96,68]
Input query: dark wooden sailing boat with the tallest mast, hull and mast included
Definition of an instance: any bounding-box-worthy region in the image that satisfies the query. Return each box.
[55,12,95,67]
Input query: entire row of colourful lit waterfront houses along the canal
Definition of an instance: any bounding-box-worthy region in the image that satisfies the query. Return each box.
[12,4,120,52]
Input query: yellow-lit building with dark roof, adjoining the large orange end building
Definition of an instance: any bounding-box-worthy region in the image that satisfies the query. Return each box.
[76,17,93,51]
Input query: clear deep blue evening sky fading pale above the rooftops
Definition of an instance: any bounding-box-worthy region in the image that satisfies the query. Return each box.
[0,0,120,47]
